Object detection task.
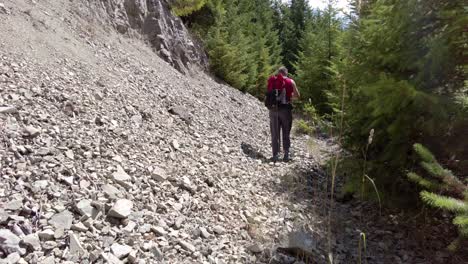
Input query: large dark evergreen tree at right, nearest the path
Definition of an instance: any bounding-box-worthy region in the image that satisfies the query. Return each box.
[336,0,466,196]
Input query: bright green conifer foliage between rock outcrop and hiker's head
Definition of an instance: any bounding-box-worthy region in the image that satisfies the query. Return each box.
[188,0,281,95]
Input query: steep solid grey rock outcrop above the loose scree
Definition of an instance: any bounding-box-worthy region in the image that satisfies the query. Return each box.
[89,0,208,73]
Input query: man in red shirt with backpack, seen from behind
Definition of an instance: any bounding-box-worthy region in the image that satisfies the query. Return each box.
[265,67,300,162]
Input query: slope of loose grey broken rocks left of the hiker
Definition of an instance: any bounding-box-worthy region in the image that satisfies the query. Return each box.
[0,0,318,263]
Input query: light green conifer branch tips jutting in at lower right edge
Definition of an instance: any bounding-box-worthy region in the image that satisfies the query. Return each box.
[408,144,468,249]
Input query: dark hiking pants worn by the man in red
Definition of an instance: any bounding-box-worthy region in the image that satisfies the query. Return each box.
[270,106,292,157]
